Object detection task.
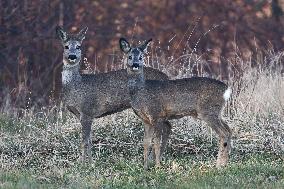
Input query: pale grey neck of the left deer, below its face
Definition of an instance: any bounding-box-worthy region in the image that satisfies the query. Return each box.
[62,60,81,85]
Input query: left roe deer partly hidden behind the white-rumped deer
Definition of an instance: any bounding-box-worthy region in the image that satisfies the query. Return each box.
[56,27,171,161]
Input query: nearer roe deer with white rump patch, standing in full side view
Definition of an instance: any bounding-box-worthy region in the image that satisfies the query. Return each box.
[119,38,232,169]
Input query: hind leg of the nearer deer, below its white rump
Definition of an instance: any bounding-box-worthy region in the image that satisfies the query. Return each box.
[201,115,232,168]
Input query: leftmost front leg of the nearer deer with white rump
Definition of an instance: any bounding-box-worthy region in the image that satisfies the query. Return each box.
[143,123,155,170]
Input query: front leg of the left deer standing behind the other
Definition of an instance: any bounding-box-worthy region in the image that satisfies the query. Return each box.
[80,114,93,163]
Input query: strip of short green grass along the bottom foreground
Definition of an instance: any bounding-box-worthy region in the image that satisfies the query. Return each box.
[0,154,284,189]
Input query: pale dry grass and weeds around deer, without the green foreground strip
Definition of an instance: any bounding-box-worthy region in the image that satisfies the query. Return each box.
[0,50,284,188]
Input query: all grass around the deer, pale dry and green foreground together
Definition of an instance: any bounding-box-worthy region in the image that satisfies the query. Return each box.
[0,50,284,189]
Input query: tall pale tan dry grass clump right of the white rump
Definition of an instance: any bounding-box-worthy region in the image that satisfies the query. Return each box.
[228,53,284,153]
